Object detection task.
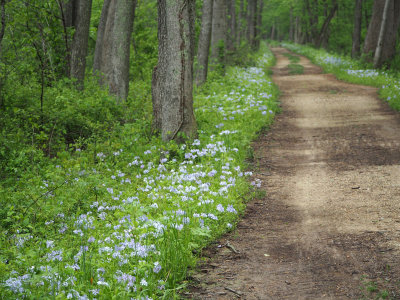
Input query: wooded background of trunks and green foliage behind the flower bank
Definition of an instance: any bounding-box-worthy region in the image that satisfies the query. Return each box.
[0,0,400,183]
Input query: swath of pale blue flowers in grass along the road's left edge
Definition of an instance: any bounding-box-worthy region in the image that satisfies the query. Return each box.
[1,48,274,299]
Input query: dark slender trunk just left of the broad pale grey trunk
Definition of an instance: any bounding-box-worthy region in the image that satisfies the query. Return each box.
[70,0,92,89]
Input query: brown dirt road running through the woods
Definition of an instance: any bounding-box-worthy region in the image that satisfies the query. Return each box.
[186,48,400,299]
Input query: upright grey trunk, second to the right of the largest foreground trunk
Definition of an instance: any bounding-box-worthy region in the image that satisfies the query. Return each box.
[211,0,227,65]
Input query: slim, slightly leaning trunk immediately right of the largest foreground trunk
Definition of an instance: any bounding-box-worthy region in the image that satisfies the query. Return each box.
[196,0,213,85]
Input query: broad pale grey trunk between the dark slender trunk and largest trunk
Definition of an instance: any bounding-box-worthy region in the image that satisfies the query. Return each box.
[94,0,136,102]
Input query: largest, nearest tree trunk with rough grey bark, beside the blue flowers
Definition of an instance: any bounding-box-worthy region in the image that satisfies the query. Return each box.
[152,0,197,141]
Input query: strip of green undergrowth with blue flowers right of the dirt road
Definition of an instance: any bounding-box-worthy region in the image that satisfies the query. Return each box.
[282,43,400,111]
